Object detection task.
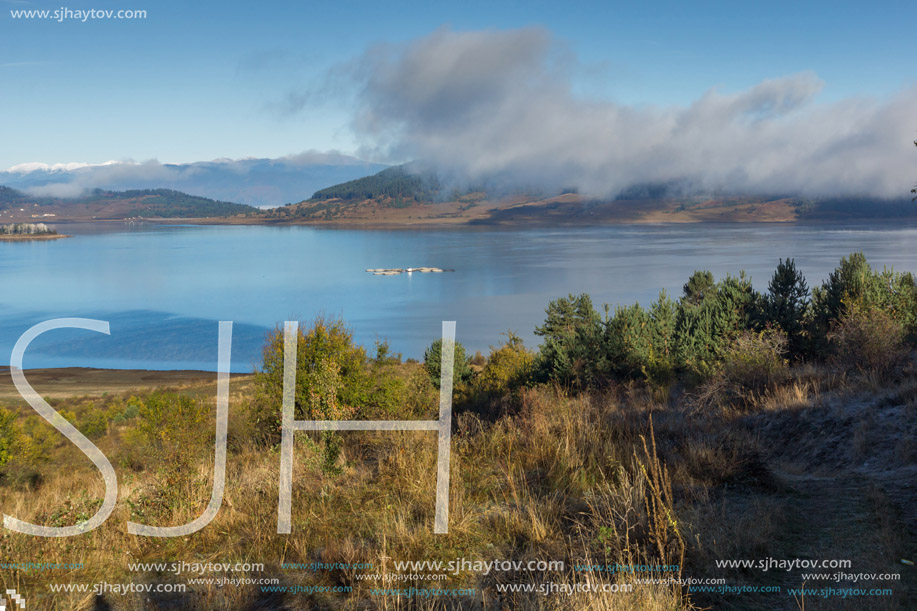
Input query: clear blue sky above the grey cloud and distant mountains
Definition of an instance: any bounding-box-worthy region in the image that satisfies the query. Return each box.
[0,0,917,169]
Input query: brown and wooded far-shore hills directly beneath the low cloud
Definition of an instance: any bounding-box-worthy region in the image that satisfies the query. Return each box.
[259,166,917,225]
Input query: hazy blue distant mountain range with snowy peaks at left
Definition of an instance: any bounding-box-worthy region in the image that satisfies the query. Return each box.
[0,152,387,207]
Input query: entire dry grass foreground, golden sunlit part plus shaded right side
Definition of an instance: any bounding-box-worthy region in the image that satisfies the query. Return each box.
[0,358,917,611]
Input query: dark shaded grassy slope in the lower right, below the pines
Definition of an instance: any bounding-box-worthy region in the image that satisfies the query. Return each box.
[689,367,917,611]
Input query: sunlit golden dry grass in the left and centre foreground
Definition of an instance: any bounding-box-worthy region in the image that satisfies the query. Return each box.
[0,376,686,609]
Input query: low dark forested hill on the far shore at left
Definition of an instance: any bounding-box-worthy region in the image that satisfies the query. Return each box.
[0,186,257,221]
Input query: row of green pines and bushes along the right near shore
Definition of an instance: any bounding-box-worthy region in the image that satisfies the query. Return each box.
[425,252,917,391]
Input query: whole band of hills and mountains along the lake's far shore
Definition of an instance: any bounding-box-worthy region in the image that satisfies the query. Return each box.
[0,160,917,226]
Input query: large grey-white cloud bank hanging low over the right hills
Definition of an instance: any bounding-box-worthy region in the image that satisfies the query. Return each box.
[320,28,917,197]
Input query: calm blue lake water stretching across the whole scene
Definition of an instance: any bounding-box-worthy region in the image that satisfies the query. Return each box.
[0,224,917,372]
